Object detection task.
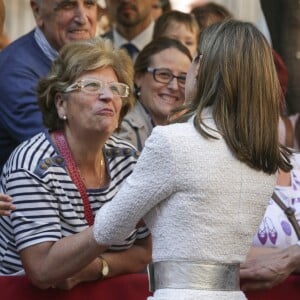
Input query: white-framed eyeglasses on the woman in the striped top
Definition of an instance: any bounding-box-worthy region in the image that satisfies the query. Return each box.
[64,79,129,97]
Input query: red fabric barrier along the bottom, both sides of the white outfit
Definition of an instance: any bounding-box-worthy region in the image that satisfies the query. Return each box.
[0,273,300,300]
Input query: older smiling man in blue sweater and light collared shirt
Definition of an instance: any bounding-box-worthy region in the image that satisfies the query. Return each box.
[0,0,98,172]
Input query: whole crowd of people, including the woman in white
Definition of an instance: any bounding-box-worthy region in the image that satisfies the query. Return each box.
[0,0,300,300]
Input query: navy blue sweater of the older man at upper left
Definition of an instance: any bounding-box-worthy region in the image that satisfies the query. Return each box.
[0,30,51,172]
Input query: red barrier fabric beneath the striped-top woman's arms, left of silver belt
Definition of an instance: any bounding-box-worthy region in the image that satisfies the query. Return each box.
[0,273,150,300]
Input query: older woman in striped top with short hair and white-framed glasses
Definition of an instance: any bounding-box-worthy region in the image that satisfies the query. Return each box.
[0,39,151,289]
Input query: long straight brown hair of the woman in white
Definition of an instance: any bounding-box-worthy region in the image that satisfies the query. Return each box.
[185,20,291,174]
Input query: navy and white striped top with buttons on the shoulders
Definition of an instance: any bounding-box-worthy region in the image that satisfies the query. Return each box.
[0,132,150,275]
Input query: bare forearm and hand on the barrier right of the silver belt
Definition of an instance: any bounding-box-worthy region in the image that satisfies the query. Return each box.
[240,245,300,291]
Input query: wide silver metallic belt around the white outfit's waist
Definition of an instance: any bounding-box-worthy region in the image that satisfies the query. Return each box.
[148,261,240,292]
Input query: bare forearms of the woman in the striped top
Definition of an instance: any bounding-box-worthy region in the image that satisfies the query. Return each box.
[20,227,151,290]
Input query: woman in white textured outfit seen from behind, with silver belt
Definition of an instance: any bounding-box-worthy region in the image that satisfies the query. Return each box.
[93,20,291,300]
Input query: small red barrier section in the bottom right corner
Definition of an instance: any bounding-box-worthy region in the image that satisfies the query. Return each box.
[246,275,300,300]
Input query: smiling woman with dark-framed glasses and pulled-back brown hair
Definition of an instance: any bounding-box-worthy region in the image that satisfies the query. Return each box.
[118,37,192,151]
